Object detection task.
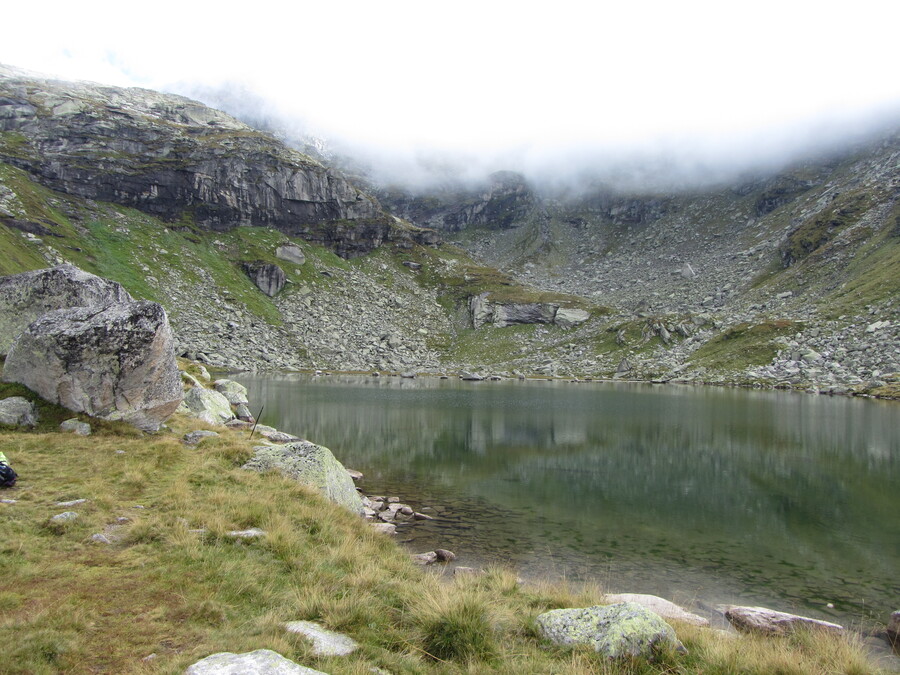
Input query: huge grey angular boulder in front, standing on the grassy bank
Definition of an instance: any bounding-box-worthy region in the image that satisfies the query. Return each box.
[3,301,182,431]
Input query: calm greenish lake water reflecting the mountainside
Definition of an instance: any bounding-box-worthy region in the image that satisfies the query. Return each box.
[237,376,900,621]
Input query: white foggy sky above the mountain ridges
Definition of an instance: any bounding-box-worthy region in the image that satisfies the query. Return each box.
[0,0,900,190]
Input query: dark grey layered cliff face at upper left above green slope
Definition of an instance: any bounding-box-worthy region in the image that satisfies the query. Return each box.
[0,66,436,253]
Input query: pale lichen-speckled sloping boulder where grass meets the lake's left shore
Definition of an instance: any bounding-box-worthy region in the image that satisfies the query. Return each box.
[243,441,363,515]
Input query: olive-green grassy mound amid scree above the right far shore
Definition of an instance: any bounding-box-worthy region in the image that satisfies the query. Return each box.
[691,319,803,371]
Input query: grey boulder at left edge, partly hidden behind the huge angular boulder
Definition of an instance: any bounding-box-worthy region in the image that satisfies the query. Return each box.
[0,265,133,354]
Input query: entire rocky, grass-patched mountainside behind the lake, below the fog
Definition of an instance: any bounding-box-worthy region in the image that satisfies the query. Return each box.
[0,67,900,395]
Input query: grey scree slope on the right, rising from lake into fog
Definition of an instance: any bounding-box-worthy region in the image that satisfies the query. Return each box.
[380,132,900,391]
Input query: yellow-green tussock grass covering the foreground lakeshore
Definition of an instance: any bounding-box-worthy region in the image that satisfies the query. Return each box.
[0,418,875,675]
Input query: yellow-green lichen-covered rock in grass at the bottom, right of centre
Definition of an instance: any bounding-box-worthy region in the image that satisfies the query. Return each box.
[536,602,683,658]
